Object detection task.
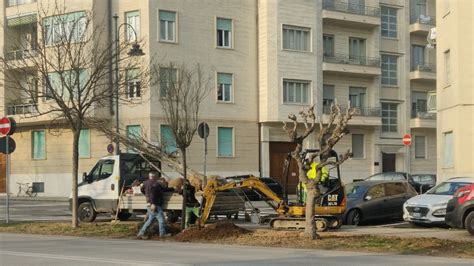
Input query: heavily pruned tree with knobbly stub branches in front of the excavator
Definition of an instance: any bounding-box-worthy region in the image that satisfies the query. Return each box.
[283,104,355,239]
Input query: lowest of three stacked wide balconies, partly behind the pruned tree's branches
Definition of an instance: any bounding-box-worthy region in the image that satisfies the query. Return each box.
[323,105,382,126]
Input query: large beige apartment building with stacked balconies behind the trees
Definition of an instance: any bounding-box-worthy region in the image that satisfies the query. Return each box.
[0,0,437,196]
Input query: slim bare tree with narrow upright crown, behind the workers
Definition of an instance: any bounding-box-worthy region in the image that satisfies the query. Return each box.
[158,63,210,229]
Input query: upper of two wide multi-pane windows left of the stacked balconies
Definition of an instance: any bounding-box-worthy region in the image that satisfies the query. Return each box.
[283,25,310,51]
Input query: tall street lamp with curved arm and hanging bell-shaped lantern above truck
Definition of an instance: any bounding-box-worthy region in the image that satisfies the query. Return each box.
[113,14,145,155]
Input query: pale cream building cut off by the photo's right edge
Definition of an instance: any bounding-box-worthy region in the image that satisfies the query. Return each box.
[436,0,474,180]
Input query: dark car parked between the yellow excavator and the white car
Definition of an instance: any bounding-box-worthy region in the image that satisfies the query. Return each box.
[342,180,417,225]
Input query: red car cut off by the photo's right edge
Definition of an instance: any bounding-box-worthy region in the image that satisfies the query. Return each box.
[444,184,474,235]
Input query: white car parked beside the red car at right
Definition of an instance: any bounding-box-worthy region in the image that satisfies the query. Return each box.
[403,177,474,224]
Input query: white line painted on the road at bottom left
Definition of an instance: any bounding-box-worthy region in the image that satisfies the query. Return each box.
[0,250,186,265]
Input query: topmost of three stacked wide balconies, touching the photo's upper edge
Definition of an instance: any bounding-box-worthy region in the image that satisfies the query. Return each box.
[322,0,380,28]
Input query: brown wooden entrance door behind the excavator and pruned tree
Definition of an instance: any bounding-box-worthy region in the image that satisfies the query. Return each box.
[270,142,298,194]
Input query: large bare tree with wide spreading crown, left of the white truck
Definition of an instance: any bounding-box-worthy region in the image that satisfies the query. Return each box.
[0,2,149,227]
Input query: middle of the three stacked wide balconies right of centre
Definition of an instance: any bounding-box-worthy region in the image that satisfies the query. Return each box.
[323,54,381,76]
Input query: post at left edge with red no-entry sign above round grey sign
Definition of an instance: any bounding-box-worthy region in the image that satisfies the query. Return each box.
[0,117,16,223]
